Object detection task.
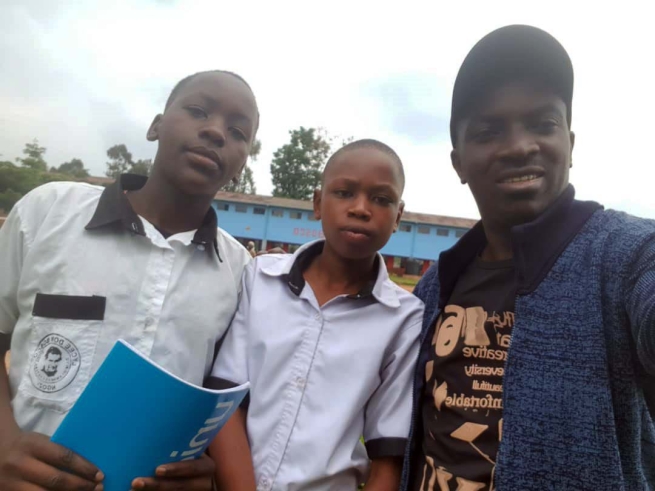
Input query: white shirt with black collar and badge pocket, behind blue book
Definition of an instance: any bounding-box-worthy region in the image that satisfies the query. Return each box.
[0,175,251,435]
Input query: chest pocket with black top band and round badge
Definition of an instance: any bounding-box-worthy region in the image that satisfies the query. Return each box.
[17,293,106,413]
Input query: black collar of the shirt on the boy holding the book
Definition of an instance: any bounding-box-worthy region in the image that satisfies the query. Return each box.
[86,174,218,252]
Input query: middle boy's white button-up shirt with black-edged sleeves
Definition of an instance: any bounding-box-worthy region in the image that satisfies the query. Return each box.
[208,241,423,491]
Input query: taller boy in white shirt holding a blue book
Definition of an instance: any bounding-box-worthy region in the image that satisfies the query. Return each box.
[0,71,259,491]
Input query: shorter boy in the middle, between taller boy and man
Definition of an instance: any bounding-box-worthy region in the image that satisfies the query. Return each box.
[208,140,423,491]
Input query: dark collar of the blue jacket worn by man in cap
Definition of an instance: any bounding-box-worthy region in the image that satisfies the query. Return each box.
[439,184,603,306]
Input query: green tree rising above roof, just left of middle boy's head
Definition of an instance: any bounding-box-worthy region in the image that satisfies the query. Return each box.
[271,130,330,200]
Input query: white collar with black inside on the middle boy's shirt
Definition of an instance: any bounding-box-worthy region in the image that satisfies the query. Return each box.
[262,240,400,308]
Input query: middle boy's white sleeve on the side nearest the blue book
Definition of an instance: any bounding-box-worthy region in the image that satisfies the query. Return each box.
[205,261,254,389]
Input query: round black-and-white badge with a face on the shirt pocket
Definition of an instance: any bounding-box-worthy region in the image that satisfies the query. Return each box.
[30,333,81,393]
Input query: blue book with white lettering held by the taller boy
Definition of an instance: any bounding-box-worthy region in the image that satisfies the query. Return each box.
[52,340,249,491]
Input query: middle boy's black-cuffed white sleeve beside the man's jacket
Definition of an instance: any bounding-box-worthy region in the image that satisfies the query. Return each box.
[364,315,422,459]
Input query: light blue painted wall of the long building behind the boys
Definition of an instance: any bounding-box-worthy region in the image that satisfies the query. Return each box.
[214,200,466,260]
